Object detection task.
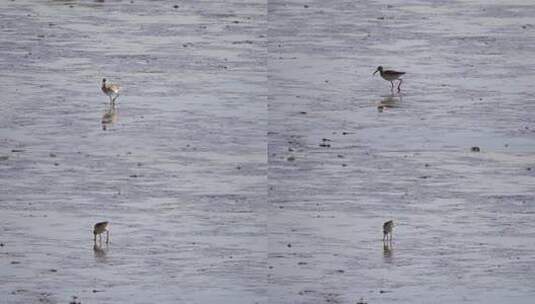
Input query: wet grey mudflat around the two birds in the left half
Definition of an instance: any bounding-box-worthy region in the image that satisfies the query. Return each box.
[0,0,267,303]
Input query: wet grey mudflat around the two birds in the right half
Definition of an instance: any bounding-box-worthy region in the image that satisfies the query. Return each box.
[268,1,535,304]
